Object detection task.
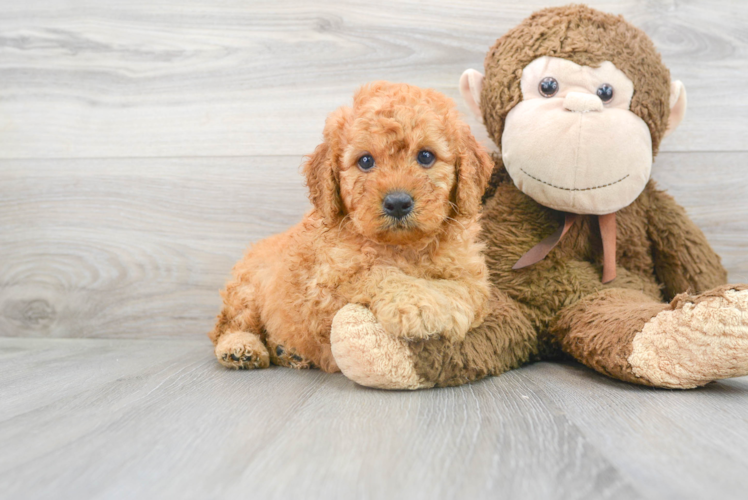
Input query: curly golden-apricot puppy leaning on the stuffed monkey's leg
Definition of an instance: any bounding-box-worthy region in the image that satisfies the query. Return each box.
[209,82,493,372]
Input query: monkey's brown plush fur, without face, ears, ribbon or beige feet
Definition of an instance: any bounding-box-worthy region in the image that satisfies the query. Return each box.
[394,6,727,386]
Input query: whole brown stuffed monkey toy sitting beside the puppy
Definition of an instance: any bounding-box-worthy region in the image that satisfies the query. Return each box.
[331,5,748,389]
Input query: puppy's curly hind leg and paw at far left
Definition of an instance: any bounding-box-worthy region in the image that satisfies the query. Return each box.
[208,280,270,370]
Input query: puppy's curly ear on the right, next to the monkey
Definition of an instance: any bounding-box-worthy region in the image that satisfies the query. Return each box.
[455,123,494,217]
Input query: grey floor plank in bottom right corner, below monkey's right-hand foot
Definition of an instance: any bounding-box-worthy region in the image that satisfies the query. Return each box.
[522,363,748,500]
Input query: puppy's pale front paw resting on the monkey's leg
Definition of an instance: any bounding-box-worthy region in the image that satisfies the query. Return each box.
[371,287,474,341]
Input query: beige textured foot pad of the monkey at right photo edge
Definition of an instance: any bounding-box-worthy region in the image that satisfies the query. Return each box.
[628,289,748,389]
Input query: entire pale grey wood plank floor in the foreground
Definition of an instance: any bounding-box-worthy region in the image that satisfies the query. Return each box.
[0,339,748,500]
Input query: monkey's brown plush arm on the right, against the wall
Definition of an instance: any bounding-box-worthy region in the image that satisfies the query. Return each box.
[645,181,727,300]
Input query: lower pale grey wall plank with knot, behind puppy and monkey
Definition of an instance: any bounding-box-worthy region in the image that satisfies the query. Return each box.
[0,153,748,338]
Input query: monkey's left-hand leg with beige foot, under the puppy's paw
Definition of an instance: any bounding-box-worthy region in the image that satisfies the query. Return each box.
[330,289,538,389]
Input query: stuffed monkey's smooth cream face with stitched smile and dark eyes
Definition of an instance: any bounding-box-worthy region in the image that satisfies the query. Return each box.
[501,56,652,214]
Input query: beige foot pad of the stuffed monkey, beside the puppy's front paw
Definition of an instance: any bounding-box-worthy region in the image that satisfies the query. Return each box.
[330,304,434,389]
